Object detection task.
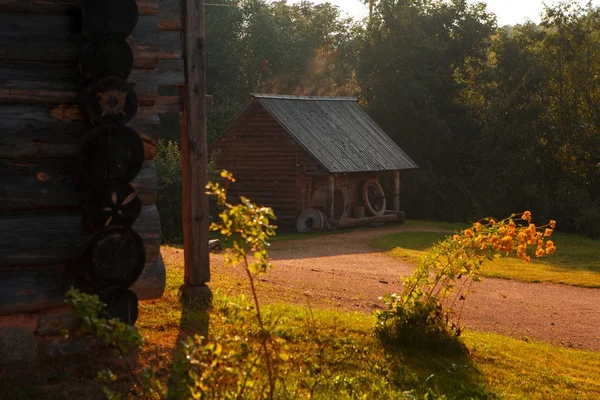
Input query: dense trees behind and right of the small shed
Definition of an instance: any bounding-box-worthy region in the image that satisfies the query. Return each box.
[156,0,600,236]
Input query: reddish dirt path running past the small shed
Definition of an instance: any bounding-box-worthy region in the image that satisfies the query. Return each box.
[214,226,600,351]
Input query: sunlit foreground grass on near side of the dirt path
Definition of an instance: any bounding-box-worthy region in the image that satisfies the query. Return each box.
[138,247,600,399]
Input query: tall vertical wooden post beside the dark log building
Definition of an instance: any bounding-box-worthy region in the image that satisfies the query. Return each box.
[181,0,211,302]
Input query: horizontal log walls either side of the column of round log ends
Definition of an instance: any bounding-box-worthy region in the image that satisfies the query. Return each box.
[0,0,184,324]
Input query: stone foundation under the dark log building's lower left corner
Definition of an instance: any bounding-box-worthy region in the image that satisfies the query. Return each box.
[0,307,91,364]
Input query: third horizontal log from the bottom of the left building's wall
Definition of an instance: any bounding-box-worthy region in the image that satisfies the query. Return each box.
[0,159,158,213]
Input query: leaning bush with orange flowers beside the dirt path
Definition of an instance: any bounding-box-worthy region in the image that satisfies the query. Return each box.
[376,211,556,345]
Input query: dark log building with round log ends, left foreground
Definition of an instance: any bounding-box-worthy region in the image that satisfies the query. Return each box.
[0,0,207,361]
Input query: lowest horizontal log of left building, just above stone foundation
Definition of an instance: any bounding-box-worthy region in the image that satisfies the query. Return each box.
[0,257,166,315]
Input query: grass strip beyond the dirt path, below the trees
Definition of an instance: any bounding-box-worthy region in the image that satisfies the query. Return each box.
[372,228,600,288]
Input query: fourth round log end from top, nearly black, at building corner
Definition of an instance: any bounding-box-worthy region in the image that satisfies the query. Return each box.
[81,125,144,183]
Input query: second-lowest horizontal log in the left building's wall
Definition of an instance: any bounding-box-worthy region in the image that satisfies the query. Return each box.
[0,206,161,267]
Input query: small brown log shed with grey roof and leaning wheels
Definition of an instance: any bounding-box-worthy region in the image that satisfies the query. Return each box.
[212,94,417,232]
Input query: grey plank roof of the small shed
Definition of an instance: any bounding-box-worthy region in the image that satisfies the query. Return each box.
[251,94,418,173]
